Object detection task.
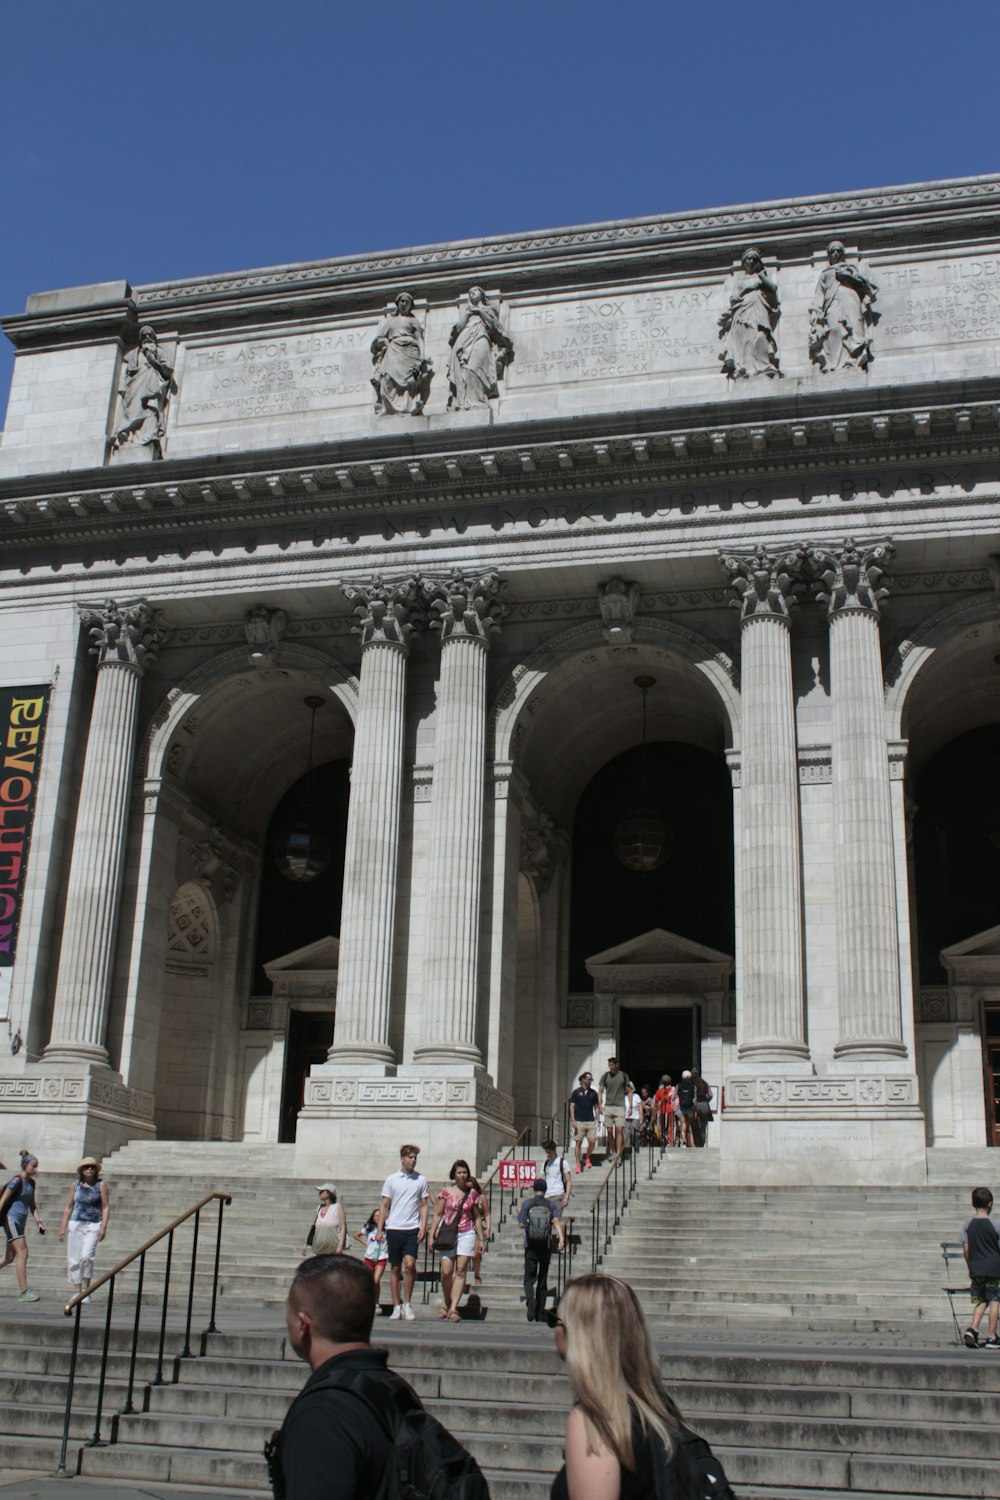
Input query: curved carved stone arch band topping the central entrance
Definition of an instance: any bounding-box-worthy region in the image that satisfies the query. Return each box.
[490,617,741,761]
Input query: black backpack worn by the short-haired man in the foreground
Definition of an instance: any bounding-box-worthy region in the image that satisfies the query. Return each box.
[264,1371,490,1500]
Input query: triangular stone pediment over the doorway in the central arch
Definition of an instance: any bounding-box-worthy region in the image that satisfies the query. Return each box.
[586,927,733,1002]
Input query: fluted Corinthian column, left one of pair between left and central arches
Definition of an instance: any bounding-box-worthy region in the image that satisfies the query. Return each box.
[330,575,421,1065]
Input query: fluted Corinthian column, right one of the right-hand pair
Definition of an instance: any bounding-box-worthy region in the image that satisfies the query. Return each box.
[810,537,906,1058]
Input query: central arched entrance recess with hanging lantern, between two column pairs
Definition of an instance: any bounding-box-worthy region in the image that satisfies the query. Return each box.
[490,623,738,1124]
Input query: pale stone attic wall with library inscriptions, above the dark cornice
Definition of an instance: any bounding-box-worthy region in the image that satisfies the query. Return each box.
[0,179,1000,486]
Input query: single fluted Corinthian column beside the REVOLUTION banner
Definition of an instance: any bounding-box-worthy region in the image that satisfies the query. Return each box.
[45,599,165,1065]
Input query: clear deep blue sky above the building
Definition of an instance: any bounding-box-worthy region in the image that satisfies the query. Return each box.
[0,0,1000,408]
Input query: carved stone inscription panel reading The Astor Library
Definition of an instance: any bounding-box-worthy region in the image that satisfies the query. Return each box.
[175,318,376,426]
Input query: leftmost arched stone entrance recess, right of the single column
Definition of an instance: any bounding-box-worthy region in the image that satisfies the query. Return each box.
[120,648,352,1140]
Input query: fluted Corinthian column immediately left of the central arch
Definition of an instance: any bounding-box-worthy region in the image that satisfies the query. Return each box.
[414,573,502,1064]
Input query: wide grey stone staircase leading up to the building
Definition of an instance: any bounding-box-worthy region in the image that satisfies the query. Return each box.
[0,1148,1000,1500]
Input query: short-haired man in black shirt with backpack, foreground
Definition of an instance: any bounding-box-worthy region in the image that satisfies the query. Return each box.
[264,1256,489,1500]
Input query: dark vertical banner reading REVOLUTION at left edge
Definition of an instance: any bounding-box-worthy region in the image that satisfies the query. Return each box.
[0,687,49,996]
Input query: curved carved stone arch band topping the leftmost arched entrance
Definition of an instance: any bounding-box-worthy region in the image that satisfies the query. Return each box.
[138,641,358,777]
